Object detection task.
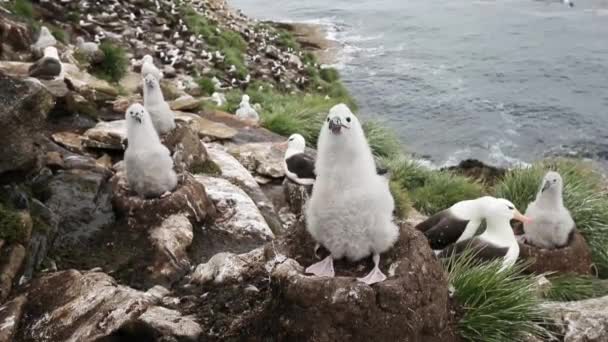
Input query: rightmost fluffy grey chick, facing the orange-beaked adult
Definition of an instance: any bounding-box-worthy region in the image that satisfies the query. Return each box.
[524,172,574,249]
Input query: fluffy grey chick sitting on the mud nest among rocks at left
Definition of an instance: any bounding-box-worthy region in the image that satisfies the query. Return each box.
[125,103,177,197]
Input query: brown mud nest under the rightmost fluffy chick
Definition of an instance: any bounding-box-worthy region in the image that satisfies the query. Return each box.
[519,231,593,274]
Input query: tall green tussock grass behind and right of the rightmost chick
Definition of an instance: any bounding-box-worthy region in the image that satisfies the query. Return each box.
[496,159,608,277]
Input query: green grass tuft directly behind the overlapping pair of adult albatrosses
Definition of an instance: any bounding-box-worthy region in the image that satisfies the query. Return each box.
[412,171,484,215]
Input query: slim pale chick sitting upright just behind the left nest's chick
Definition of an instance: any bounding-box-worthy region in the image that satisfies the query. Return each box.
[144,74,175,134]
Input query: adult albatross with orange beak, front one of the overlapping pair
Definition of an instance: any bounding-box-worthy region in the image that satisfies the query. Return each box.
[439,198,530,269]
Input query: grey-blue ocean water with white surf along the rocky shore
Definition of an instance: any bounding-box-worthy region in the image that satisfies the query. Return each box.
[231,0,608,166]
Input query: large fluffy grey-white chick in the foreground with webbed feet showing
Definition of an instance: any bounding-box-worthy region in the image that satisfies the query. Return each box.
[306,104,399,284]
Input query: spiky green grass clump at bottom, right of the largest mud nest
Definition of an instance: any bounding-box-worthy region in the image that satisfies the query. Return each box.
[445,253,551,342]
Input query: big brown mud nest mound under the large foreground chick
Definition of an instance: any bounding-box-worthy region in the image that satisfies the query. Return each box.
[266,224,455,341]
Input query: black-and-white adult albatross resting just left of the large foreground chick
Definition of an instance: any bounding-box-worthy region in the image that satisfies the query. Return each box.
[283,134,317,185]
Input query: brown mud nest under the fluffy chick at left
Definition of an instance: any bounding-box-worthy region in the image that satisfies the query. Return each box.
[111,172,216,230]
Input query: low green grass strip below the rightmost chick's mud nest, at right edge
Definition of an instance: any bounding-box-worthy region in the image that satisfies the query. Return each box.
[544,274,608,302]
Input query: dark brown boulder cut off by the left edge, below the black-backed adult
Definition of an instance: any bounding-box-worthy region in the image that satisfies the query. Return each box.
[0,73,55,174]
